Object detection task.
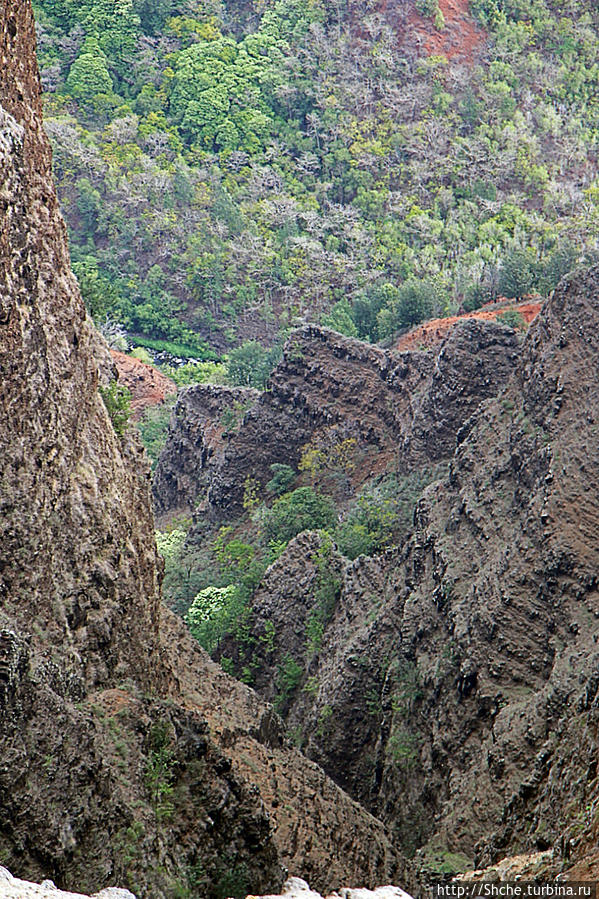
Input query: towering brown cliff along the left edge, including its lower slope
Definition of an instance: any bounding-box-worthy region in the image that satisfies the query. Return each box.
[0,0,408,899]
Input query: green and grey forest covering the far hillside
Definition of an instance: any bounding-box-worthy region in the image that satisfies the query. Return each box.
[35,0,599,359]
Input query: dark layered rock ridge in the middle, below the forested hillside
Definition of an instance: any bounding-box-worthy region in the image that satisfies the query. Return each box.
[154,321,518,519]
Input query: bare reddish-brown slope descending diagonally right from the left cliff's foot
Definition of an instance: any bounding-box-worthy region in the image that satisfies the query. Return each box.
[163,609,415,892]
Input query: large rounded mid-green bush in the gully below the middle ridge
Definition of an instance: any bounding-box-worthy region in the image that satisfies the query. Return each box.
[264,487,337,541]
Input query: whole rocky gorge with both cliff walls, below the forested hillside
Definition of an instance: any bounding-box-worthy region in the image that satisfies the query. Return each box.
[0,0,599,899]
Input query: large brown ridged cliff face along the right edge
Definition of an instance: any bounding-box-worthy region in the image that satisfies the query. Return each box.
[216,269,599,871]
